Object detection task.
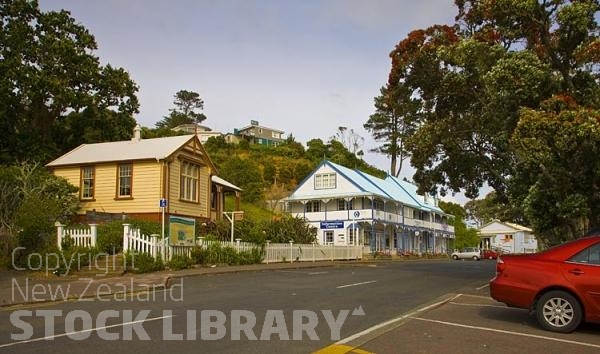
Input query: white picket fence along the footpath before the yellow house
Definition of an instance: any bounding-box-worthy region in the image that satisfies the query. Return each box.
[56,223,363,264]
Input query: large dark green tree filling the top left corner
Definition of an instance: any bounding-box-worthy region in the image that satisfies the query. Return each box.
[0,0,139,163]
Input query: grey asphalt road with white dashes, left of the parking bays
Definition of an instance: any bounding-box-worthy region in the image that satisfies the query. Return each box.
[0,261,495,354]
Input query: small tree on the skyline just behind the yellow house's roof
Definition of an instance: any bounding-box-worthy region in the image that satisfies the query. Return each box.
[156,90,206,129]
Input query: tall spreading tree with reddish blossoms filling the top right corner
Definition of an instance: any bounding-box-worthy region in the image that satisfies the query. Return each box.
[380,0,600,201]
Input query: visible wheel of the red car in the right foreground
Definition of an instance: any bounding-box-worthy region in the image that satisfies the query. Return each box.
[535,290,583,333]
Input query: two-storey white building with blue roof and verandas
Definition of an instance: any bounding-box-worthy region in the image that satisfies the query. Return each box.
[286,160,454,254]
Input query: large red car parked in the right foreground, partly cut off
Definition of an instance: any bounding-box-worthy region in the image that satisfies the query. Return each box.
[490,235,600,333]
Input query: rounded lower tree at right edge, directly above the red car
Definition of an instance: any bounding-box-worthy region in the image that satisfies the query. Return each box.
[510,97,600,245]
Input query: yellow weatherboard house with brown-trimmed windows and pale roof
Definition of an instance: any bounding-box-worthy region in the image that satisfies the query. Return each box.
[46,125,241,222]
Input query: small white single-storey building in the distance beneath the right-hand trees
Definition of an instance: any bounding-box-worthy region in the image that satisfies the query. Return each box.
[479,220,538,253]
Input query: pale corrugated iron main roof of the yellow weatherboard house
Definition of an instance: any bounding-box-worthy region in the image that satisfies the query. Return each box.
[46,134,195,167]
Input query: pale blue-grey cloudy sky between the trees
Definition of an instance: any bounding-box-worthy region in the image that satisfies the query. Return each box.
[39,0,474,204]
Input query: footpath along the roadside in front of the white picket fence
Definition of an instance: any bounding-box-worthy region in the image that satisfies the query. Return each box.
[0,261,346,308]
